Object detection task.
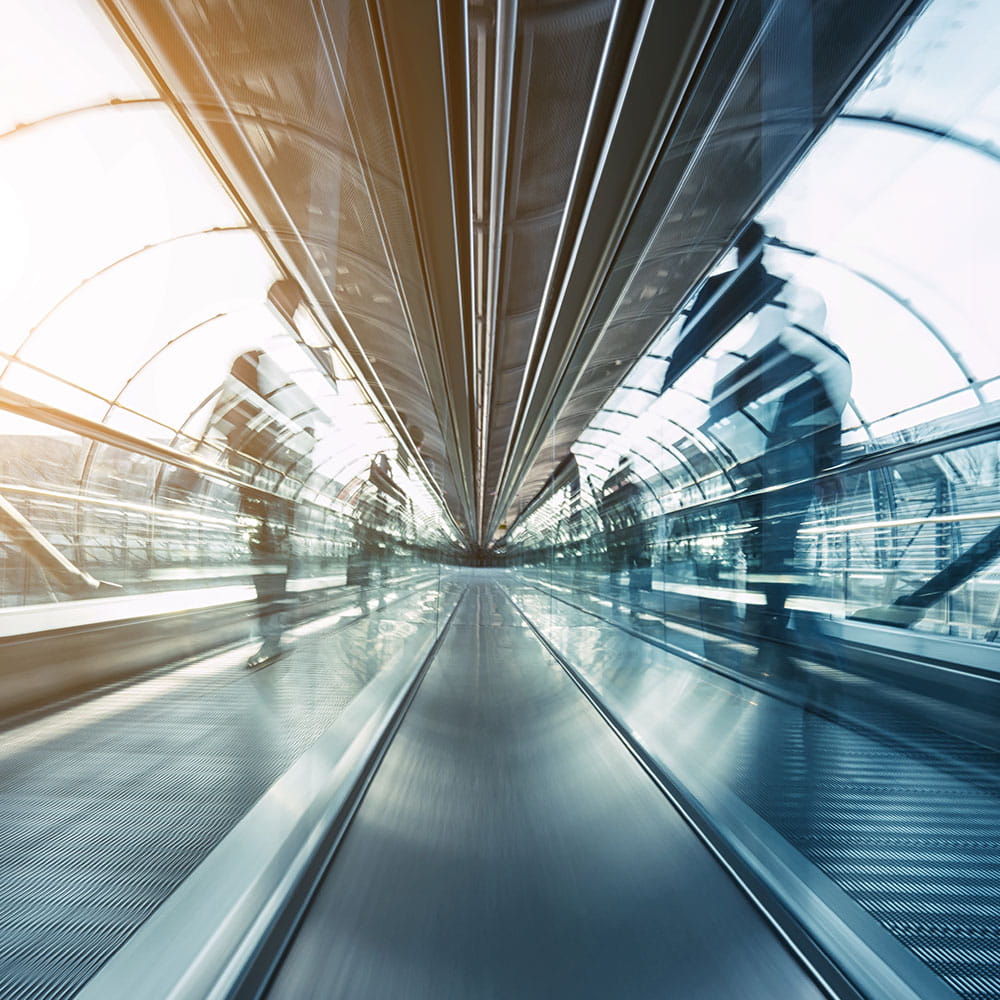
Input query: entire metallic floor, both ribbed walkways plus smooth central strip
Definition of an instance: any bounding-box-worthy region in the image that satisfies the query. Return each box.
[0,570,1000,998]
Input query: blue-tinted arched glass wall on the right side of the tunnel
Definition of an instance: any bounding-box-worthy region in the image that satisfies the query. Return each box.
[505,0,1000,644]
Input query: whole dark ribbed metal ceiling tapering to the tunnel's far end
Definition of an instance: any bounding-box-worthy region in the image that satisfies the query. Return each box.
[102,0,914,545]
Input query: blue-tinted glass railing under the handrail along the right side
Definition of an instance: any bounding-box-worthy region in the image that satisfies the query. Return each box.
[523,416,1000,641]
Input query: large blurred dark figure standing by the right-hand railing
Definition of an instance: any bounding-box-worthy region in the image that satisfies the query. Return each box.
[684,222,851,639]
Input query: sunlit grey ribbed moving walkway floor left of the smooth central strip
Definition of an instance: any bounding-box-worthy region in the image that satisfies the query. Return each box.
[0,586,458,1000]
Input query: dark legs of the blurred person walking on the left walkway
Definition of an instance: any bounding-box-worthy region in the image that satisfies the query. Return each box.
[240,490,290,667]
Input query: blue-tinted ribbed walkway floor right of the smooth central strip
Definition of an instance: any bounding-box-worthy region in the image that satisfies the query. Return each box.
[517,589,1000,1000]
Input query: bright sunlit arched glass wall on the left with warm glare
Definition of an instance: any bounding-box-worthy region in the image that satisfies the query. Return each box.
[0,0,455,608]
